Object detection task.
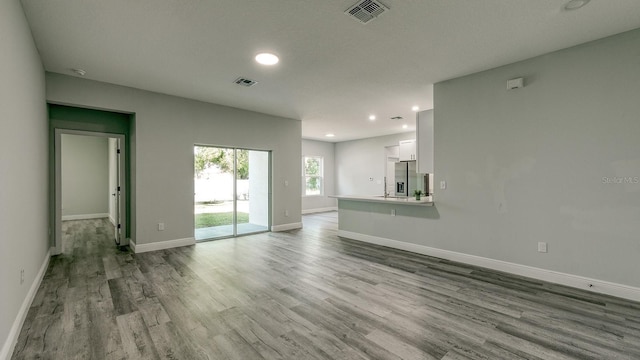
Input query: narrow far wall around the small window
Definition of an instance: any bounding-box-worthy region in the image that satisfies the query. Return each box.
[300,139,338,214]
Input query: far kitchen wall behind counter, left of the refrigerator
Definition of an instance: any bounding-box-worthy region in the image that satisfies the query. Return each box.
[335,132,416,195]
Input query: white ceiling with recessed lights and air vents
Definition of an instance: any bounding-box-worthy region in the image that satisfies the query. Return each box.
[22,0,640,141]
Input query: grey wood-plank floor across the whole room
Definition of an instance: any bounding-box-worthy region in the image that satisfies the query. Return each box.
[13,213,640,360]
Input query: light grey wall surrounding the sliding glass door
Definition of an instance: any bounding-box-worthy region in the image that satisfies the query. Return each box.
[47,73,301,245]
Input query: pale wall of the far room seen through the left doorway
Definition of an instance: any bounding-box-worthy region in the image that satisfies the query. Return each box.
[60,134,112,220]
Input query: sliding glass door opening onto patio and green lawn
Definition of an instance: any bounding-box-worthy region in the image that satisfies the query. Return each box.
[198,145,271,241]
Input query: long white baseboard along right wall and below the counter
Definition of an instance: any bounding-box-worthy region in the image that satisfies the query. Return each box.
[338,230,640,301]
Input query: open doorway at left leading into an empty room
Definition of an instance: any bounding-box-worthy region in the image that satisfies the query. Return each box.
[55,129,126,254]
